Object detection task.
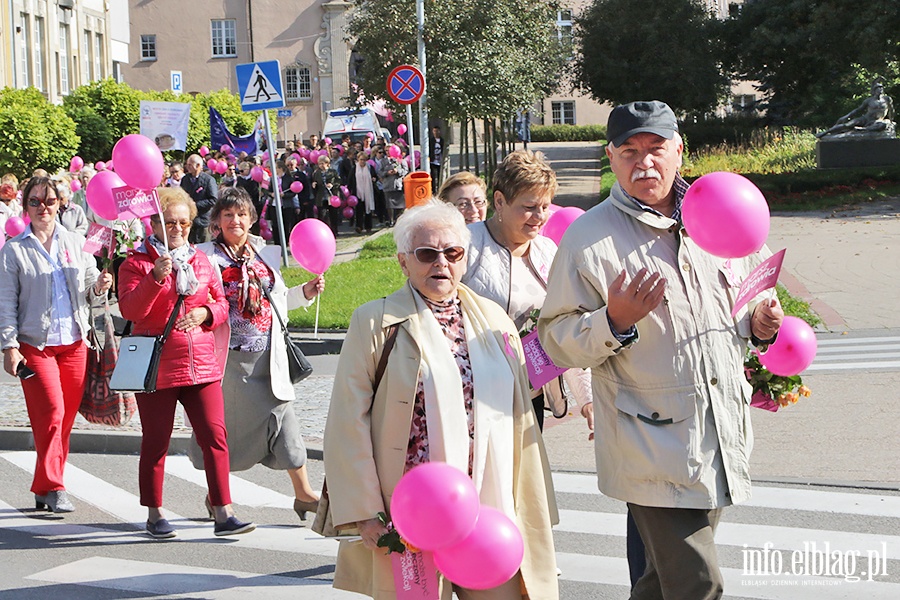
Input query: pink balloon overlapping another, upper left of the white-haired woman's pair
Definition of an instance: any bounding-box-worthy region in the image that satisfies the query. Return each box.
[391,462,482,552]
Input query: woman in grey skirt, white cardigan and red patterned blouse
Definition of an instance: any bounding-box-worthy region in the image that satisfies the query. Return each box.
[191,188,325,519]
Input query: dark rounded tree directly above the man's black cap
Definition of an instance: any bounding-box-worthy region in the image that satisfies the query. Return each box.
[575,0,729,112]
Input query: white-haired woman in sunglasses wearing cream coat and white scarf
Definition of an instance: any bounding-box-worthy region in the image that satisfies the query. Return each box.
[324,201,559,600]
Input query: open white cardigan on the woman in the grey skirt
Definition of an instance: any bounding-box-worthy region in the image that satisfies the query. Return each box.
[197,236,312,402]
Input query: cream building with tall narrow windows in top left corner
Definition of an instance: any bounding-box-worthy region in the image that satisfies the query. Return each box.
[0,0,129,104]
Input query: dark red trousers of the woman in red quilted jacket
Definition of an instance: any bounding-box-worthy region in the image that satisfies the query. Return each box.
[135,381,231,508]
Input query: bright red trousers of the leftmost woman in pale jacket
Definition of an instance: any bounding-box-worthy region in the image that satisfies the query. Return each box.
[19,340,87,496]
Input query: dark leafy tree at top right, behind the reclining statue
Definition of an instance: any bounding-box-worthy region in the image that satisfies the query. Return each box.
[725,0,900,126]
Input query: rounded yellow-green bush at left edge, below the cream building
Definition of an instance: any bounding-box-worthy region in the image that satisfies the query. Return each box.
[0,87,78,178]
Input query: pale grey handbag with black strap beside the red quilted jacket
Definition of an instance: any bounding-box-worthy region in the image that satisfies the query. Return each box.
[109,295,184,394]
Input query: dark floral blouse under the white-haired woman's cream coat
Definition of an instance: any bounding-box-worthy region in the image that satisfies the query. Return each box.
[404,297,475,477]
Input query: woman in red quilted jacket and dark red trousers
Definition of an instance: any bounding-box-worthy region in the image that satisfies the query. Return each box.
[119,188,256,538]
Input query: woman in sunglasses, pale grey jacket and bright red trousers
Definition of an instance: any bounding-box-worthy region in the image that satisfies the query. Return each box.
[0,177,112,513]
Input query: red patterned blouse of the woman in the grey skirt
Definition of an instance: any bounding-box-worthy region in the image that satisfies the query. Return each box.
[211,245,275,352]
